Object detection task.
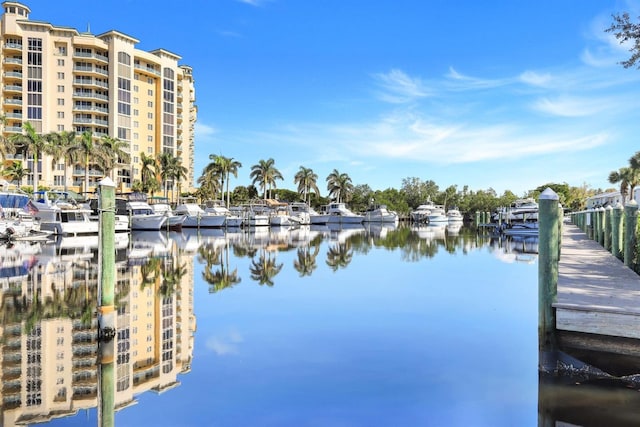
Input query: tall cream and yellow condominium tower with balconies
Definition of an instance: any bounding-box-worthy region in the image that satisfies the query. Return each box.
[0,1,197,192]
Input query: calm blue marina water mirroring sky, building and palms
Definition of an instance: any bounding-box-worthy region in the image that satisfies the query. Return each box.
[2,222,632,426]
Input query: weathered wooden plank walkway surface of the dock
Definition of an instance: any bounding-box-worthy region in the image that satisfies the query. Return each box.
[553,223,640,339]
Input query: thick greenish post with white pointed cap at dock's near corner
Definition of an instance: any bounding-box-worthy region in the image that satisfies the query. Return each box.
[538,188,560,364]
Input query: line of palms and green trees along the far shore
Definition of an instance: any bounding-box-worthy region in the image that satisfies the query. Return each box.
[193,154,602,214]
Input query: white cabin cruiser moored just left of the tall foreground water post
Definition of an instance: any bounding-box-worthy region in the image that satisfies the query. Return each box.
[32,191,100,236]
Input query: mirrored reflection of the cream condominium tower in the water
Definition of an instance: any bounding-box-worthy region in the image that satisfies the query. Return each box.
[0,236,195,425]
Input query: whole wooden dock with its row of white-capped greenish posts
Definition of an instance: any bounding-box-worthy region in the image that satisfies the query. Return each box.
[538,190,640,380]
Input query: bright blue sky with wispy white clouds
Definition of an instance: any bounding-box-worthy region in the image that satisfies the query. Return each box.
[32,0,640,195]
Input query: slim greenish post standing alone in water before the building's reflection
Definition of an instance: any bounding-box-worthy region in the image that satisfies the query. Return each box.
[98,177,116,427]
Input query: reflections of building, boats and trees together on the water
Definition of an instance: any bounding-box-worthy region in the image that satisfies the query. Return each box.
[0,224,537,425]
